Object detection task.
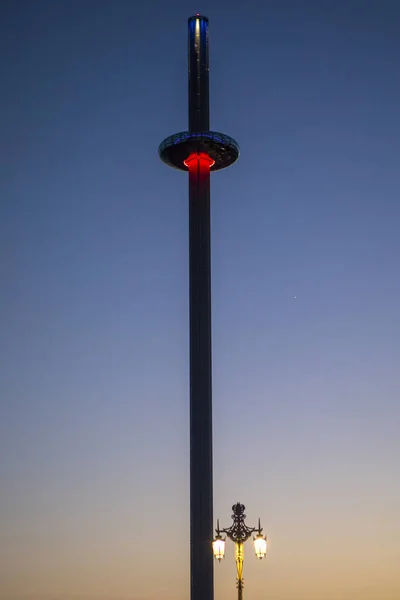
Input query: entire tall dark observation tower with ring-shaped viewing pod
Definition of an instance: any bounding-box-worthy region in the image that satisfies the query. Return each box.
[159,14,239,600]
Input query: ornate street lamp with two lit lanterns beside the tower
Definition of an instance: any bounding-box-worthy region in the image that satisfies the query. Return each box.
[213,502,267,600]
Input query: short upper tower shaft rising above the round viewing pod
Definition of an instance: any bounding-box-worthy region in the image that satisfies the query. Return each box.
[188,15,210,131]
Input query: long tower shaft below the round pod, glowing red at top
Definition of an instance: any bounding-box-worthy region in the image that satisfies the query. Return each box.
[187,155,214,600]
